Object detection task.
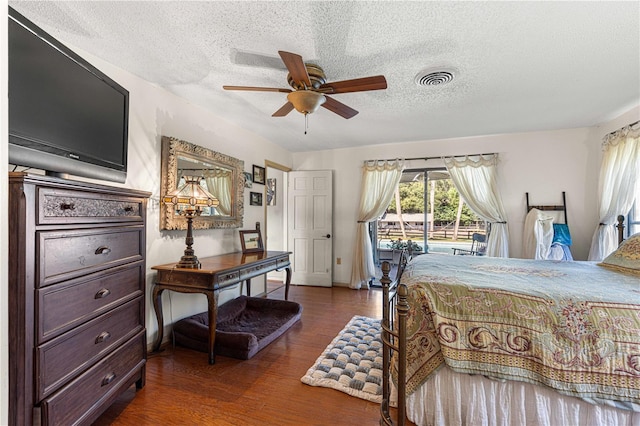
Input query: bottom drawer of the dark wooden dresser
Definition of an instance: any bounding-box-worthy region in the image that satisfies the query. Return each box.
[41,332,145,425]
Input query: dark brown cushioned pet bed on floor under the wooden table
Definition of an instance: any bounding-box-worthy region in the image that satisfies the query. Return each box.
[173,296,302,359]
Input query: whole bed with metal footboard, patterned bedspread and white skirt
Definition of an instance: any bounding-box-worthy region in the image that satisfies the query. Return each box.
[381,218,640,426]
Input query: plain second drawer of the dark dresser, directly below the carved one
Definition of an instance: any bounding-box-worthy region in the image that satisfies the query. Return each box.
[37,225,145,287]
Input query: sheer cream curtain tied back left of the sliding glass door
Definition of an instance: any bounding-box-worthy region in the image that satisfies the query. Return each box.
[349,160,404,289]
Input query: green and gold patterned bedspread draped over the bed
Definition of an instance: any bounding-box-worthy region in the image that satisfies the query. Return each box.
[402,254,640,405]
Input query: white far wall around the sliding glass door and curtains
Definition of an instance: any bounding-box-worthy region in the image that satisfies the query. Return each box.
[293,103,640,284]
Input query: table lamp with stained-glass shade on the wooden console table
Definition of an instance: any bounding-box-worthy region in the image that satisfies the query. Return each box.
[162,176,220,269]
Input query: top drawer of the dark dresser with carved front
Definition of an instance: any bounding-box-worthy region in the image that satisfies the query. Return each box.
[38,187,145,225]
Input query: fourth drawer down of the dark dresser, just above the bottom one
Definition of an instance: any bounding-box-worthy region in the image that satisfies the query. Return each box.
[36,298,144,399]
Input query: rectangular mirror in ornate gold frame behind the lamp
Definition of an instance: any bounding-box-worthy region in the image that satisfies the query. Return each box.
[160,136,244,230]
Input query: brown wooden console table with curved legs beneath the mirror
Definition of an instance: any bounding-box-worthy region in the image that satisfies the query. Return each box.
[151,251,291,364]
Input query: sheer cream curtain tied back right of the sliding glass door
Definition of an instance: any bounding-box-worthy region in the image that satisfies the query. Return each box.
[443,154,509,257]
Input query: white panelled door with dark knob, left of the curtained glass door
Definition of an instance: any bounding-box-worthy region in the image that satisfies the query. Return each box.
[288,170,333,287]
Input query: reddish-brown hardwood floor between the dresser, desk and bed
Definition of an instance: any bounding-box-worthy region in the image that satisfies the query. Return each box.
[95,286,398,426]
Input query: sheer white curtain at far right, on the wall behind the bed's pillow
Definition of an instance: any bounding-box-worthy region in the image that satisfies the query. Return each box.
[589,126,640,261]
